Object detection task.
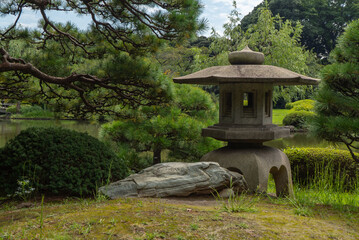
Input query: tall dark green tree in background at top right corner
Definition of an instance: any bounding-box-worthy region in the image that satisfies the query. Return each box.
[241,0,359,57]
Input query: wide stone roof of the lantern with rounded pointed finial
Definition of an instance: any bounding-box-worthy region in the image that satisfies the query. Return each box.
[173,47,320,85]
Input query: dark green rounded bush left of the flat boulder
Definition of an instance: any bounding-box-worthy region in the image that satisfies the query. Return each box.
[0,128,127,196]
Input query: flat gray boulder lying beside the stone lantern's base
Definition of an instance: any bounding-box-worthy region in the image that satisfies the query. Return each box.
[99,162,247,199]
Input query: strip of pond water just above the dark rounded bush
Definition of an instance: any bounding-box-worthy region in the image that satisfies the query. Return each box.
[0,120,100,147]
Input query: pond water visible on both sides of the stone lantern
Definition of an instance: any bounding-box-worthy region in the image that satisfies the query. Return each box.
[0,120,352,149]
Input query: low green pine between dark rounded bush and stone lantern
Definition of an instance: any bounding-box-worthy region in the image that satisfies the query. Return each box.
[101,84,220,171]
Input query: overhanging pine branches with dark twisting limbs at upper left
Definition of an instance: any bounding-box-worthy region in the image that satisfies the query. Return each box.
[0,0,205,118]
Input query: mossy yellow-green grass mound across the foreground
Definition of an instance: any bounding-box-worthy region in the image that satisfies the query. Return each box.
[0,195,359,240]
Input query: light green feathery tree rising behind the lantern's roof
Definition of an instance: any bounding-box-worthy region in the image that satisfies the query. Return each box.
[239,8,314,74]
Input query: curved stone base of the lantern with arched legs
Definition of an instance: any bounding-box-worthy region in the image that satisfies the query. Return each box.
[201,144,294,197]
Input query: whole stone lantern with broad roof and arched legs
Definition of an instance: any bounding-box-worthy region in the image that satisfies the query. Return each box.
[174,47,319,196]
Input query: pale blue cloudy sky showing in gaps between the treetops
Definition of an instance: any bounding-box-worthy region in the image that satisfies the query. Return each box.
[0,0,262,36]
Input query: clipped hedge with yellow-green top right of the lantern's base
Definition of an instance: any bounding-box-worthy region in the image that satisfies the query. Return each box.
[284,148,359,189]
